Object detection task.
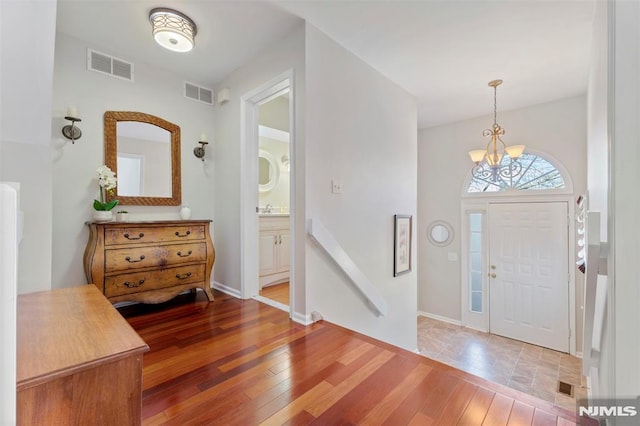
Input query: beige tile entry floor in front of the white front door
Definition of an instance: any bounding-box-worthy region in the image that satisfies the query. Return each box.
[418,316,587,411]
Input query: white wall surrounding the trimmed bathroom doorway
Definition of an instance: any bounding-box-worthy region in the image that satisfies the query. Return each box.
[213,26,305,312]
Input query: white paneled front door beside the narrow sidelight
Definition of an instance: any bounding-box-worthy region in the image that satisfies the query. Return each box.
[489,202,569,352]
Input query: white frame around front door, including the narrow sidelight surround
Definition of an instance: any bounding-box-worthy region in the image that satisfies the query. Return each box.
[460,192,580,355]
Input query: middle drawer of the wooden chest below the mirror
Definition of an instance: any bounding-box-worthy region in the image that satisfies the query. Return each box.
[104,243,207,273]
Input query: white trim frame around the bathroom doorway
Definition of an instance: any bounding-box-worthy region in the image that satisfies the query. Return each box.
[240,69,296,316]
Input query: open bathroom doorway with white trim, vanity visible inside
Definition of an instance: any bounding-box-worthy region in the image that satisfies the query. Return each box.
[240,70,295,312]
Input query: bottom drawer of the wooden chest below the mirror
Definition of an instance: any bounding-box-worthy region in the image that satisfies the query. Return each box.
[104,264,205,297]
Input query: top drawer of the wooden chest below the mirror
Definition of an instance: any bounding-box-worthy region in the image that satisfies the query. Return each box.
[104,225,205,246]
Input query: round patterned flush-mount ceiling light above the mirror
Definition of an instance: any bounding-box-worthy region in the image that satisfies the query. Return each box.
[149,7,198,52]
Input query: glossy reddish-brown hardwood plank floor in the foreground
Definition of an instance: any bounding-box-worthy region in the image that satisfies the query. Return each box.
[120,292,596,425]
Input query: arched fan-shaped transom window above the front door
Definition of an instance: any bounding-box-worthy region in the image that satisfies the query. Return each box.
[467,153,565,193]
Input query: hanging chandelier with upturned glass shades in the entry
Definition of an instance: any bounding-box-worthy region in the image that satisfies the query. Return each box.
[469,80,524,182]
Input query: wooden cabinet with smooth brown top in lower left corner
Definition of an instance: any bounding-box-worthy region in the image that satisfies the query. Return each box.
[17,285,149,425]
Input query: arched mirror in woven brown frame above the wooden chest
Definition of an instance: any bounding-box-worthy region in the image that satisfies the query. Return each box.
[104,111,182,206]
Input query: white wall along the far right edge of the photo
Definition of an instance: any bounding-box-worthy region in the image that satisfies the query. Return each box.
[588,1,640,398]
